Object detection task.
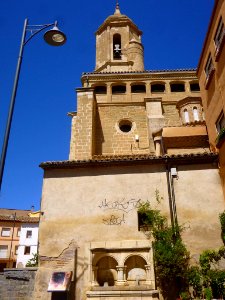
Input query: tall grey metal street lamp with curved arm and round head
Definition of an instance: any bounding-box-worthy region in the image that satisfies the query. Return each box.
[0,19,66,190]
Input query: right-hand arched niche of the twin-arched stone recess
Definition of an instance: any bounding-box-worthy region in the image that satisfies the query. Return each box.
[124,254,147,285]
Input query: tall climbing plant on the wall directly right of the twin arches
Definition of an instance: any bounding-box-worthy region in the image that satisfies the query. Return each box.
[139,202,189,299]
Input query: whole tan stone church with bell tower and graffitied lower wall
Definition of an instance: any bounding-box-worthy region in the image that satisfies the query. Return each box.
[34,5,224,300]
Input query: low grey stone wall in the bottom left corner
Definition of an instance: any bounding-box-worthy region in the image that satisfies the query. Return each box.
[0,268,37,300]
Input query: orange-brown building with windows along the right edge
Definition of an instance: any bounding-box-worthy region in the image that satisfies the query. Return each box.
[197,0,225,199]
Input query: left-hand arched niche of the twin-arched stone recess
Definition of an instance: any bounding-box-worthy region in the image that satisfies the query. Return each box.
[96,255,118,286]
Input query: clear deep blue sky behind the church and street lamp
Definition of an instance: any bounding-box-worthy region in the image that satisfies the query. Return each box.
[0,0,214,209]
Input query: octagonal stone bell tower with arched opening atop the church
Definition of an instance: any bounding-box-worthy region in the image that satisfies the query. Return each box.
[95,2,144,72]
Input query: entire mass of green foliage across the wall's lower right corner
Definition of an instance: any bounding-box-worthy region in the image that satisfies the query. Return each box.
[139,202,225,300]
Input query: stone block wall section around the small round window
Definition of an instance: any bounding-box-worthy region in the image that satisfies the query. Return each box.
[95,104,149,155]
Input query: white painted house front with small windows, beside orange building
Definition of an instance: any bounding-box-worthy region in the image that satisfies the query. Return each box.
[16,223,39,268]
